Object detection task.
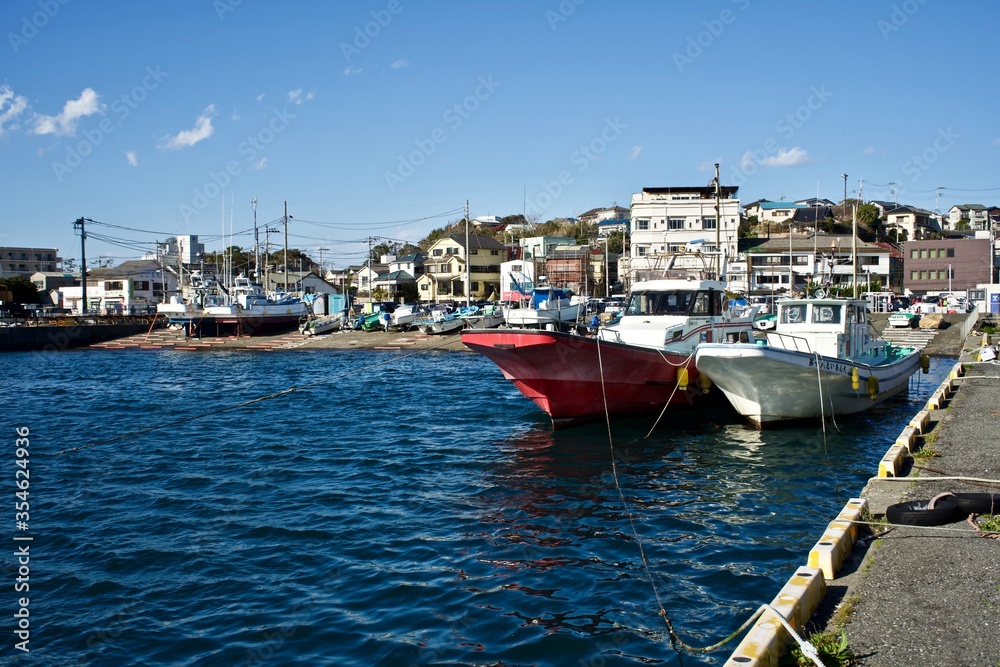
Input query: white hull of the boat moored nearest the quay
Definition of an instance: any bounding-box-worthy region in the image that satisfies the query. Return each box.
[695,344,920,428]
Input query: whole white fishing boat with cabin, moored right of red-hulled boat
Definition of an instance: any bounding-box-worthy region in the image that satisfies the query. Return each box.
[695,297,926,428]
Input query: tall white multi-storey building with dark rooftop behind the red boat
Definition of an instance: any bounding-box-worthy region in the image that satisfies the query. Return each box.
[619,184,740,281]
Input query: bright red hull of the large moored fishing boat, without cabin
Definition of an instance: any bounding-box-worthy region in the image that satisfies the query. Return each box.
[462,329,703,428]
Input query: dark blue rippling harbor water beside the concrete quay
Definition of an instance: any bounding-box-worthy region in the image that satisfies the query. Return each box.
[0,350,954,667]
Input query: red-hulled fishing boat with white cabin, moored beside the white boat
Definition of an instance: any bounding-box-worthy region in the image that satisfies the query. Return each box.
[462,260,756,429]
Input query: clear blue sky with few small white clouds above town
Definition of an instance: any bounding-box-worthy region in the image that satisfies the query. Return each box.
[0,0,1000,267]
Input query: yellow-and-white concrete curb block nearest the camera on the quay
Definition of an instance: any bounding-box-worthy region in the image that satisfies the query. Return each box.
[726,567,826,667]
